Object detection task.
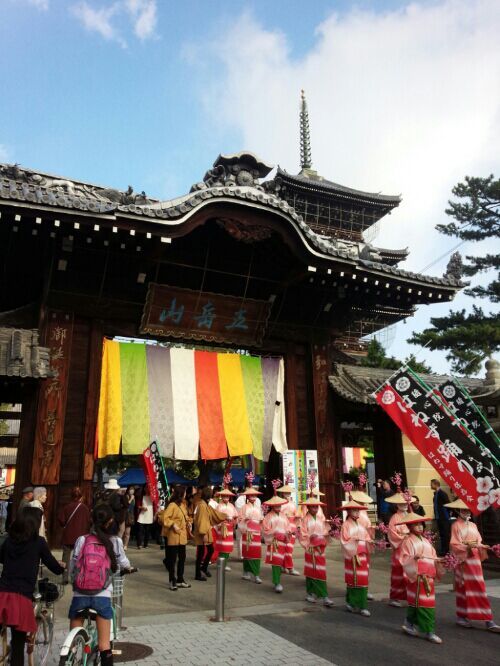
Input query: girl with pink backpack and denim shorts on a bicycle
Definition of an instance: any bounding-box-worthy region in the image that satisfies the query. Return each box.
[68,504,130,666]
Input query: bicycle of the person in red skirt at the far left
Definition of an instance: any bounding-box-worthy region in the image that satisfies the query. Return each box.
[0,565,64,666]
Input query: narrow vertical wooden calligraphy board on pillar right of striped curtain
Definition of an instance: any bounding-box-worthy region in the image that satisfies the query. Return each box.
[311,342,341,513]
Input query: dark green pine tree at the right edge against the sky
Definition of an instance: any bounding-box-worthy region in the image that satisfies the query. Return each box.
[408,175,500,375]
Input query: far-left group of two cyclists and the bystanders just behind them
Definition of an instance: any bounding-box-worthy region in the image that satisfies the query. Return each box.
[0,487,136,666]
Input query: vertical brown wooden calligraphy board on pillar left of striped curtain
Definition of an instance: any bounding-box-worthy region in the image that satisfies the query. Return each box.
[31,311,73,485]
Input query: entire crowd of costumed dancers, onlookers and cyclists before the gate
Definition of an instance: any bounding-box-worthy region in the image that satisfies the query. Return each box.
[0,479,500,666]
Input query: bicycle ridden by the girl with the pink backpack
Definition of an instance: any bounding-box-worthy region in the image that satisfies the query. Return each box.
[58,567,138,666]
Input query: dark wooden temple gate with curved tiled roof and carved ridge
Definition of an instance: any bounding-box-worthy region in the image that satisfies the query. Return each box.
[0,153,460,537]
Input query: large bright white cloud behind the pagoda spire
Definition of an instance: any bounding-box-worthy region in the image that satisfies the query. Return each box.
[189,0,500,374]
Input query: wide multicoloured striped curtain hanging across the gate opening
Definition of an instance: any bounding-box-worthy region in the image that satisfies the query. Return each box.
[96,340,288,461]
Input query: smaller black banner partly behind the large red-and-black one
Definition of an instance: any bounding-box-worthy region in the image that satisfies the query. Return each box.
[437,377,500,465]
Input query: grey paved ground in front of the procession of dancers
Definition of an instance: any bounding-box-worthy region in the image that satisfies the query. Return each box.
[51,546,500,666]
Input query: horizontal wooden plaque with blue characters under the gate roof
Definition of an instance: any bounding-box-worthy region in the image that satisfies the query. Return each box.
[140,282,271,345]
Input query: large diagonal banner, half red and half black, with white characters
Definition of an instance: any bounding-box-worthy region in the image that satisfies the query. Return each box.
[374,368,500,514]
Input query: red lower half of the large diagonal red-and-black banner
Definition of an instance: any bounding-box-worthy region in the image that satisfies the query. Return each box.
[375,384,482,515]
